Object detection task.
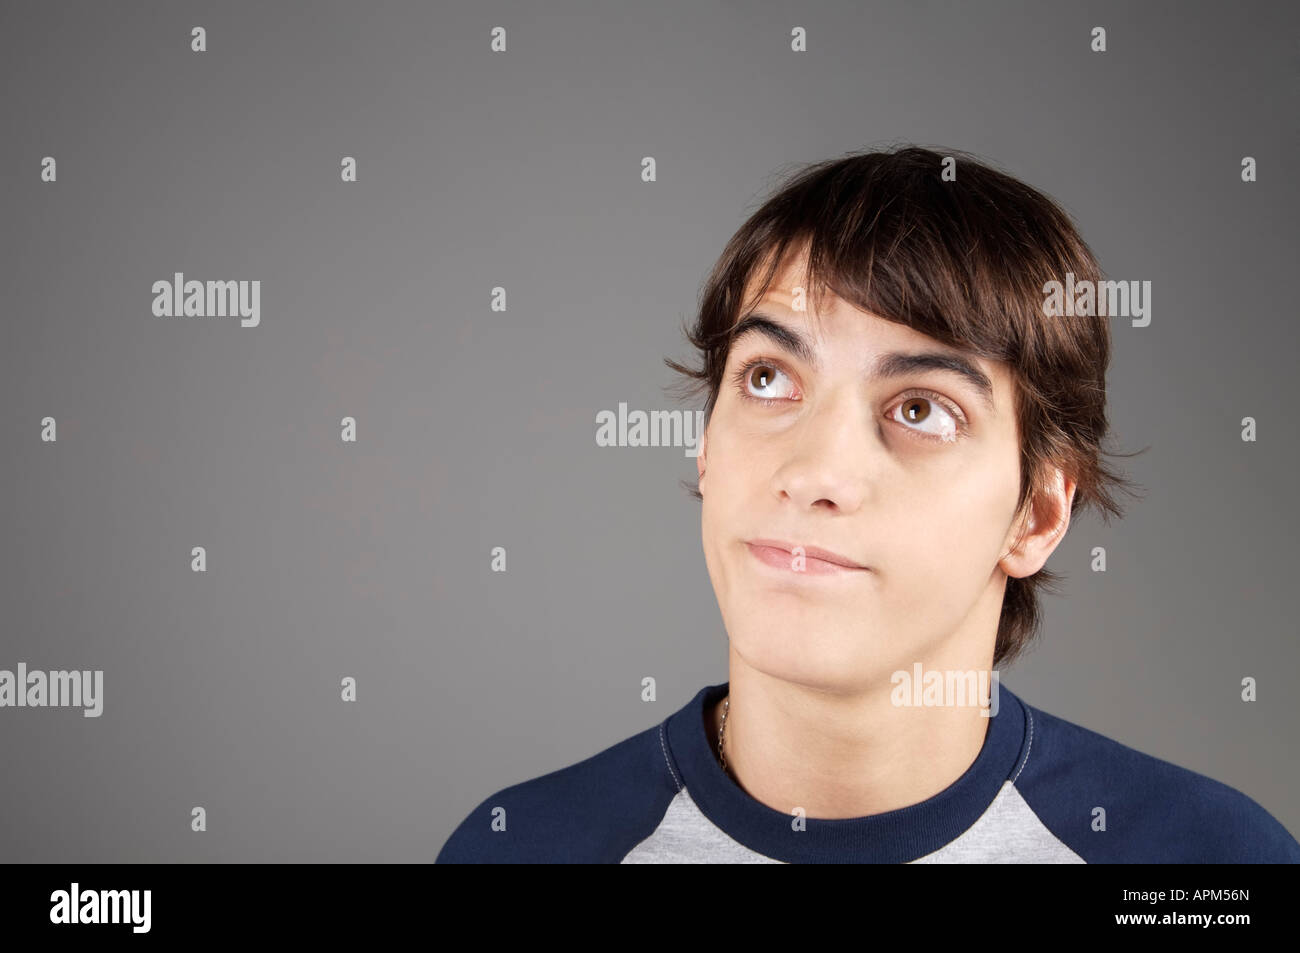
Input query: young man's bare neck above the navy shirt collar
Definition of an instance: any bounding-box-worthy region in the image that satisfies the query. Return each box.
[707,634,992,819]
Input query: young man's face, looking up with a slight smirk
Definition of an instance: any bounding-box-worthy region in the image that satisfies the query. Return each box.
[697,250,1019,690]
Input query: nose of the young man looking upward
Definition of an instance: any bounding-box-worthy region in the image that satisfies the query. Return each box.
[772,387,875,514]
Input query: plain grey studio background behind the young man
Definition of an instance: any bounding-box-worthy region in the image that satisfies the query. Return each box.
[0,0,1300,862]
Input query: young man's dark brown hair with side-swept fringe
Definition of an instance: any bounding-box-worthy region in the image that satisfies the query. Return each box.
[664,146,1141,667]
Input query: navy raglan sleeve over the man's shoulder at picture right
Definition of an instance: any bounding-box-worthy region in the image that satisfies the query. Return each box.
[1013,705,1300,863]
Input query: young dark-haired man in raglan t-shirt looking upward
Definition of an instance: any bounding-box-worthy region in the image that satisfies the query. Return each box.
[438,147,1300,863]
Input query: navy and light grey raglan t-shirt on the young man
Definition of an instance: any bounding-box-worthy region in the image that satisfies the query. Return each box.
[437,683,1300,863]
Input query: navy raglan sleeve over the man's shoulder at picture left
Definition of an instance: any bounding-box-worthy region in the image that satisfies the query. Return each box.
[436,723,681,863]
